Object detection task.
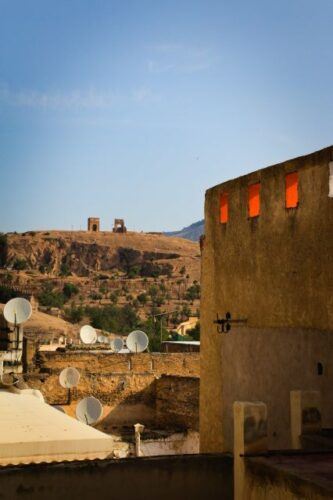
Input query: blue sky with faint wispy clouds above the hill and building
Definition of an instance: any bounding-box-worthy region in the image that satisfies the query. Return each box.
[0,0,333,231]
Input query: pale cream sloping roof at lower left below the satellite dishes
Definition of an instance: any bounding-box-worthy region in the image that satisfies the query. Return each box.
[0,390,113,465]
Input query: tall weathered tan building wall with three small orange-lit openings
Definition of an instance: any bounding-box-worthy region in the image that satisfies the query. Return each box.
[200,147,333,452]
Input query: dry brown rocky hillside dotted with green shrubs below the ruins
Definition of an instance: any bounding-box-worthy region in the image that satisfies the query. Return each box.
[0,231,200,335]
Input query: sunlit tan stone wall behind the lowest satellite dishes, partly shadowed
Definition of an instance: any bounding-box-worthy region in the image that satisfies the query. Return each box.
[27,351,199,432]
